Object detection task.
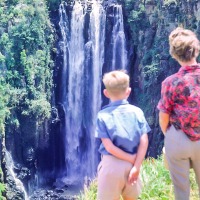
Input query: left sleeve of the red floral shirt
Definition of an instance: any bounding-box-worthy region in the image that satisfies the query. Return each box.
[157,81,173,114]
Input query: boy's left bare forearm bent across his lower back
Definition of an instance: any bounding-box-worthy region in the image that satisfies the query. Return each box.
[101,138,136,164]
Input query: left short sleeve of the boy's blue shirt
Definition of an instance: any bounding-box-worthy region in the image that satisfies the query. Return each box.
[95,114,109,138]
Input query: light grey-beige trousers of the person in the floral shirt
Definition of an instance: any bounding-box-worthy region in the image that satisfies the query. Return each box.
[165,126,200,200]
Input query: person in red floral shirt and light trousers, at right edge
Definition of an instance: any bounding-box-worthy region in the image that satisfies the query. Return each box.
[157,28,200,200]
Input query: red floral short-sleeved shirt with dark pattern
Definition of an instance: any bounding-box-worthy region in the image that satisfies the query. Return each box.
[157,65,200,141]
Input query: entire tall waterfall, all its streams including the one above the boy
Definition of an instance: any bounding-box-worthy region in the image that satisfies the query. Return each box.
[58,1,127,188]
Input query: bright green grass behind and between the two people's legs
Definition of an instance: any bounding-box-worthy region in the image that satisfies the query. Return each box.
[77,156,199,200]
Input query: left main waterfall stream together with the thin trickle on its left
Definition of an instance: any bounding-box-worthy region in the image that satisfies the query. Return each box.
[59,1,85,184]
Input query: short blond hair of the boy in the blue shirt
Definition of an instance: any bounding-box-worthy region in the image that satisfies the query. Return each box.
[103,70,130,94]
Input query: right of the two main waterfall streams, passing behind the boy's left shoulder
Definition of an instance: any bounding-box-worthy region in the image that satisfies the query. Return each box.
[85,2,106,175]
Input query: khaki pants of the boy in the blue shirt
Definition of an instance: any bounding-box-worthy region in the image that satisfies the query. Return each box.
[97,155,142,200]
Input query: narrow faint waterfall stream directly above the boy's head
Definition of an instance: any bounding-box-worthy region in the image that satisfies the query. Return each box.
[111,5,127,70]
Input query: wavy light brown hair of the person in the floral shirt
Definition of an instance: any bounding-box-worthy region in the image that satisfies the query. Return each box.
[169,27,200,62]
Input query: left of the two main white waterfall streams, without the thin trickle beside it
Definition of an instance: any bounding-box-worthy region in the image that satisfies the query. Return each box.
[65,1,85,182]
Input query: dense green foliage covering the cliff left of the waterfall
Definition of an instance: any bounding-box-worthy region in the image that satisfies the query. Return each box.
[0,0,53,134]
